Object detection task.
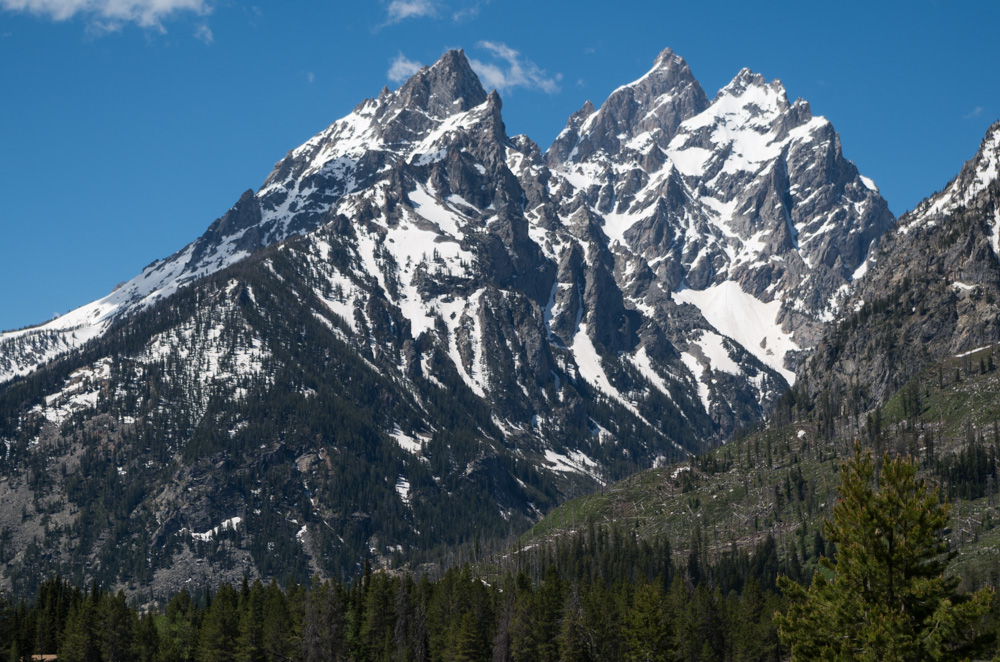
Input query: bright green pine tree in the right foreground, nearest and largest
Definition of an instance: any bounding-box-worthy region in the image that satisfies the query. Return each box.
[776,444,992,660]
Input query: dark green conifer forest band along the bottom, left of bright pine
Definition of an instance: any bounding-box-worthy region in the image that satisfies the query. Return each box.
[0,529,792,662]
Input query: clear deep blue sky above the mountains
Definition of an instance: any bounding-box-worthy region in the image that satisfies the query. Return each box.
[0,0,1000,329]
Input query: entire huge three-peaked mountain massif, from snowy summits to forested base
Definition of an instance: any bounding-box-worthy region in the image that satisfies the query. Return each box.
[0,50,893,591]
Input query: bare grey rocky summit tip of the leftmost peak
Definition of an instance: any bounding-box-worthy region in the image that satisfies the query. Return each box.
[397,50,486,117]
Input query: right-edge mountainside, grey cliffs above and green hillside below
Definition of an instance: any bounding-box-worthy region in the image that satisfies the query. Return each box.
[515,122,1000,590]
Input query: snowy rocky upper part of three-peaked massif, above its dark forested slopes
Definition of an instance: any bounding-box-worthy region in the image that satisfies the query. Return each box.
[0,49,892,440]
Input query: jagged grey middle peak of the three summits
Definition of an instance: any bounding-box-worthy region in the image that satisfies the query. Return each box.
[547,48,708,166]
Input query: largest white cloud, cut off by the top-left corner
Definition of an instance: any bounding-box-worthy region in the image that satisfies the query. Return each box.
[0,0,211,29]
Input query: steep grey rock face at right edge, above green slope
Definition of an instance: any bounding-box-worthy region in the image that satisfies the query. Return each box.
[805,123,1000,407]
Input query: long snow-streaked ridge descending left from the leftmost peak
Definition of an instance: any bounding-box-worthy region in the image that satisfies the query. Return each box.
[0,53,499,390]
